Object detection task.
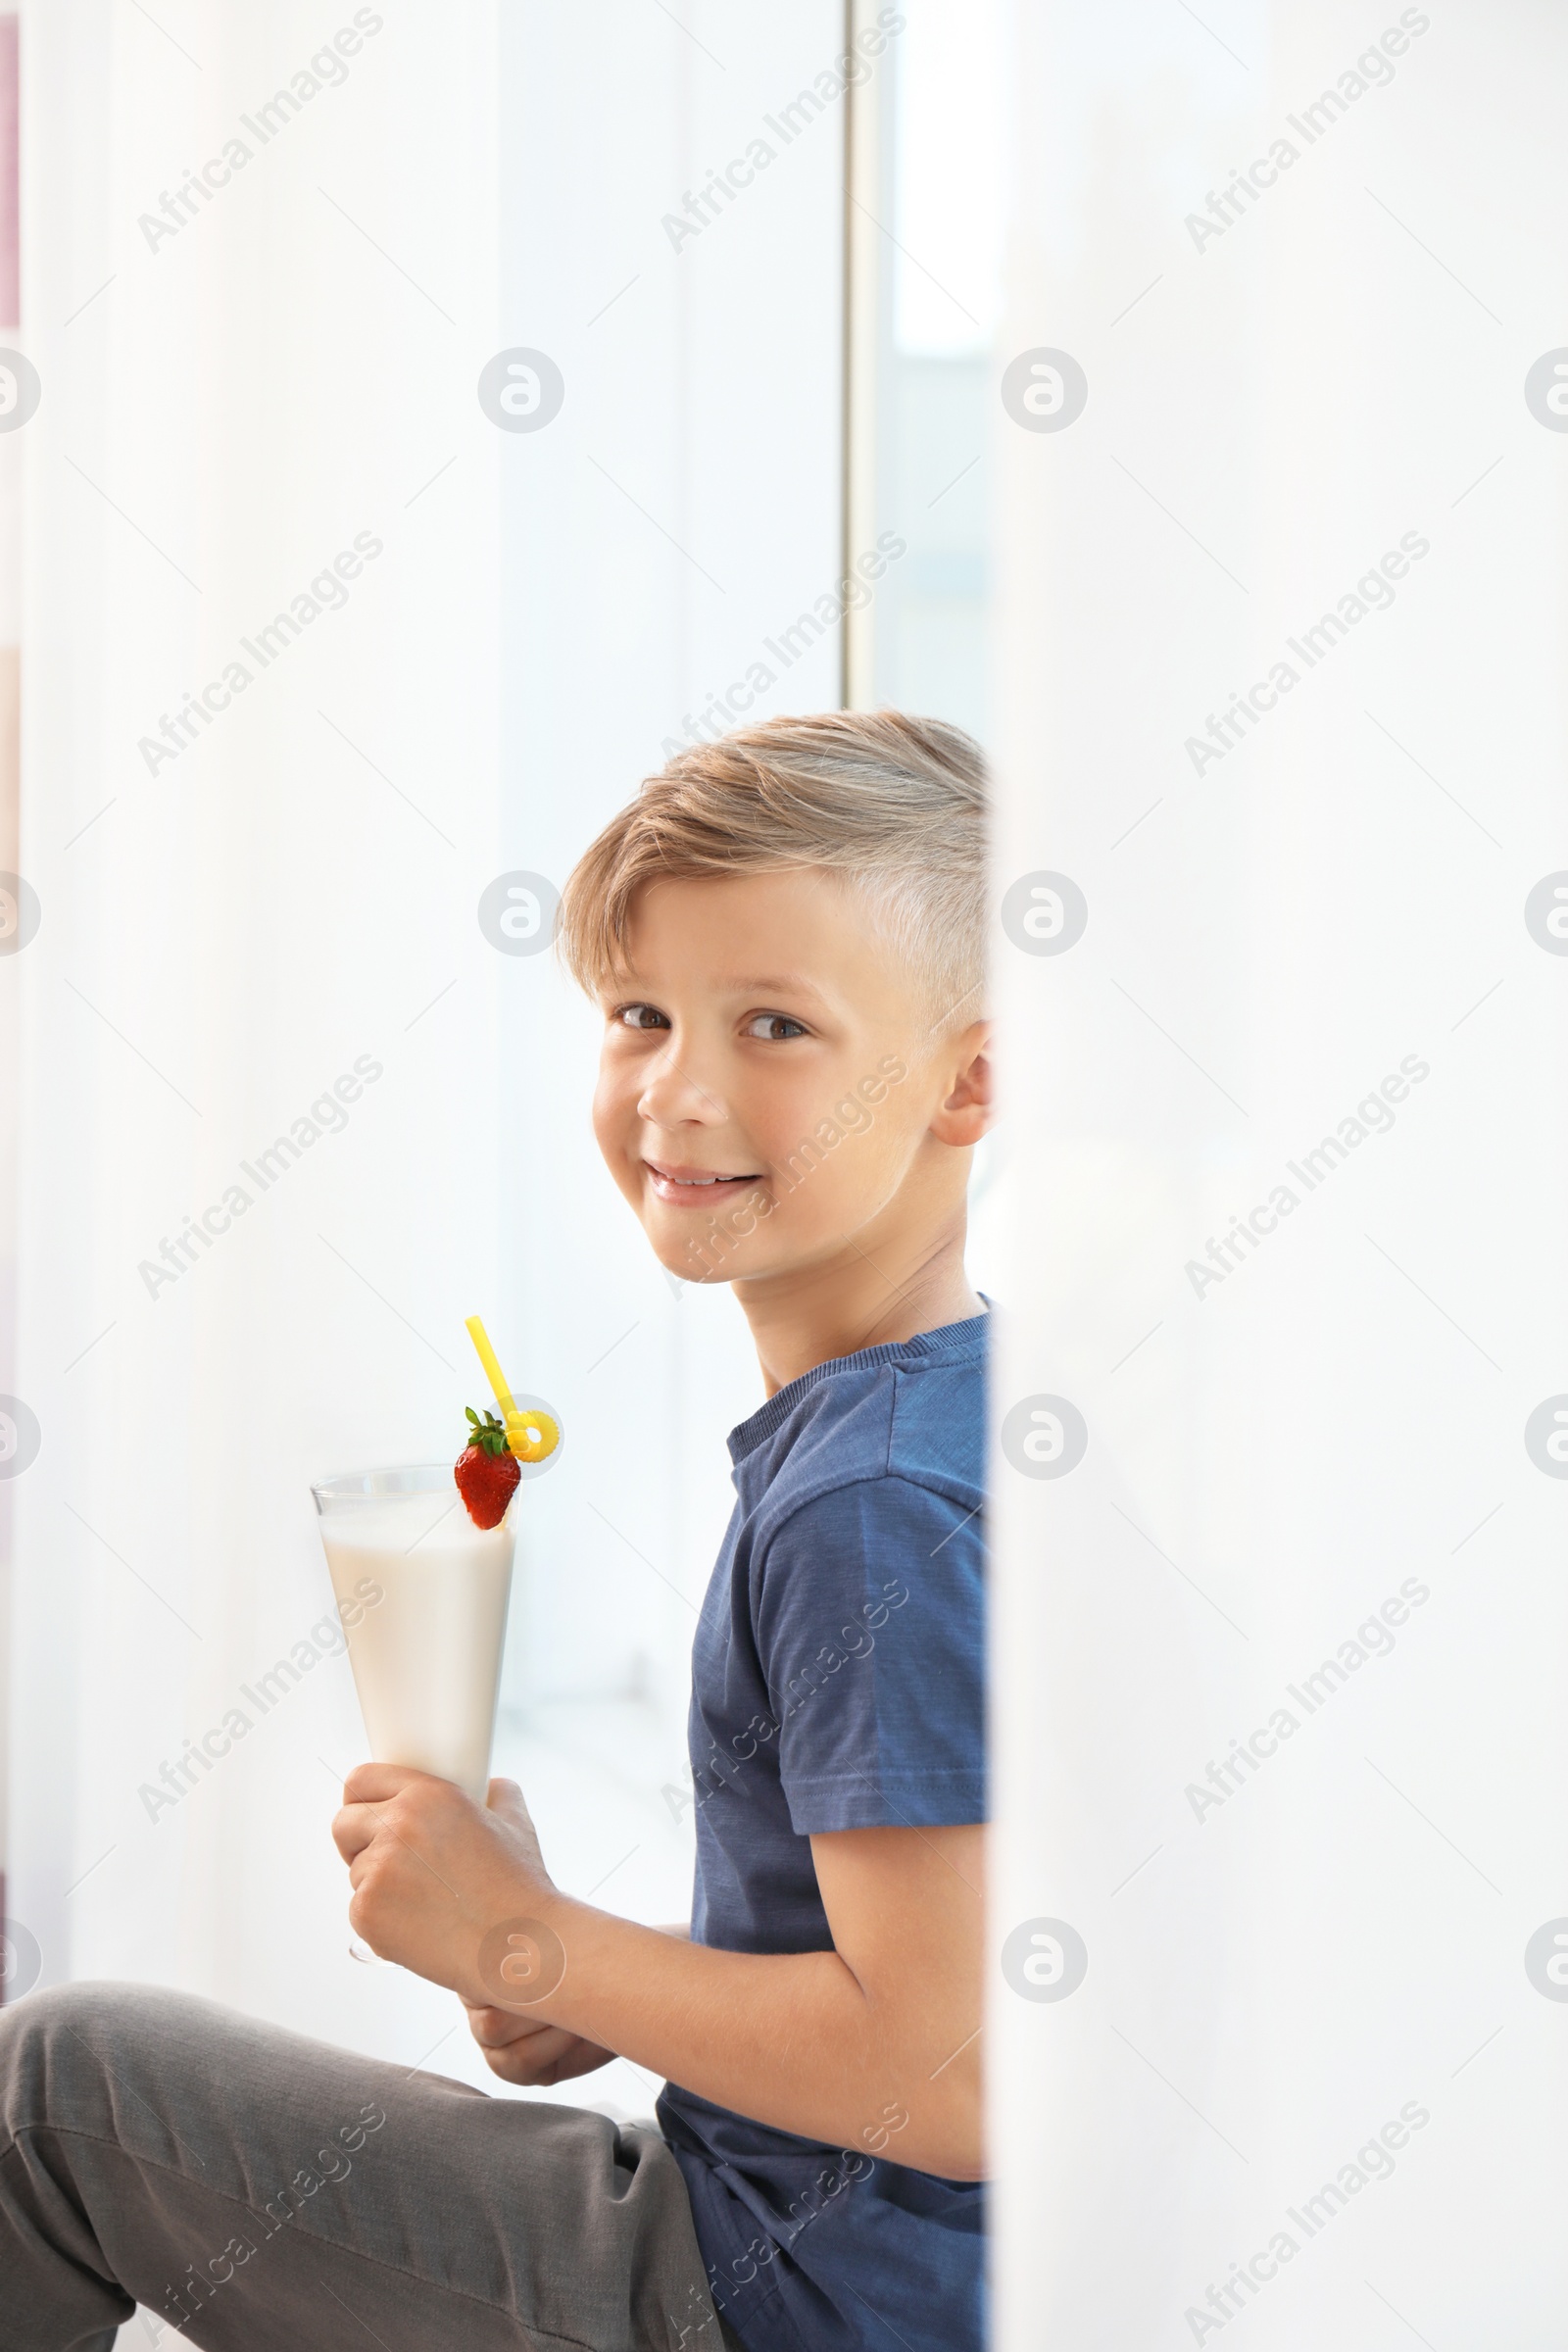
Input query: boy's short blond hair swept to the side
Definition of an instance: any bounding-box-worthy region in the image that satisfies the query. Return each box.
[558,710,987,1025]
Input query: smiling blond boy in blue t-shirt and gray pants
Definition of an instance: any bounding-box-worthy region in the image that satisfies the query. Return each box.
[0,712,990,2352]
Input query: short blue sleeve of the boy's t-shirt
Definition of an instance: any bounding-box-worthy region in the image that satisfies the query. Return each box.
[755,1477,985,1837]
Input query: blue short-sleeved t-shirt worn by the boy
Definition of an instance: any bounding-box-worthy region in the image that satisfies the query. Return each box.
[659,1315,987,2352]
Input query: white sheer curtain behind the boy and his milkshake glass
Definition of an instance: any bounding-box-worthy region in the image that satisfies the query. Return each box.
[0,0,842,2110]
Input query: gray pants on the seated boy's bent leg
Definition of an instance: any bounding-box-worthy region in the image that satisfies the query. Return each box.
[0,1985,733,2352]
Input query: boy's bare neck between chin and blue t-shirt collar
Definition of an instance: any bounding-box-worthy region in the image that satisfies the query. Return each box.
[733,1206,985,1397]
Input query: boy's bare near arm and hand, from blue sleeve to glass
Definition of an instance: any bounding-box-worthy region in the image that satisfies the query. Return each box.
[334,1764,983,2180]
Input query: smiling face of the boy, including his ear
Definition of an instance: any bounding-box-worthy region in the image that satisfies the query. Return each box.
[595,870,985,1282]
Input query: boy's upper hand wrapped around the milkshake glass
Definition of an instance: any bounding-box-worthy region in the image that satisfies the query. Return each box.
[331,1764,560,2023]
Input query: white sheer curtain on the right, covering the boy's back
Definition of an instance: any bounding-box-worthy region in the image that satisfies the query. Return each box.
[992,0,1568,2352]
